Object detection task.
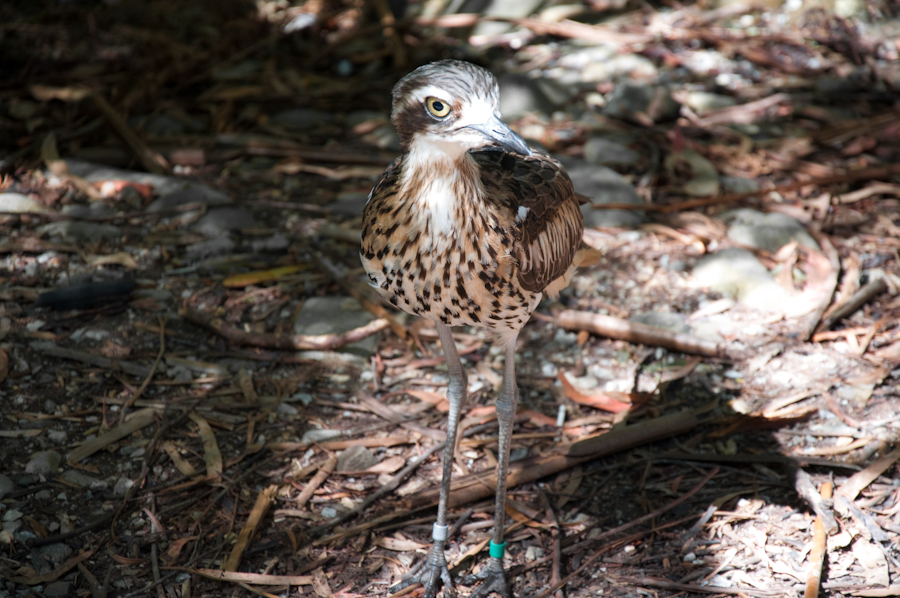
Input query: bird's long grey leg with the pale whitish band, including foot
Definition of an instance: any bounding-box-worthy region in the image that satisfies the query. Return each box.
[390,322,468,598]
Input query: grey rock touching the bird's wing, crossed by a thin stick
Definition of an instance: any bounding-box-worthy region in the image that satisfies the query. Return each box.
[560,158,645,228]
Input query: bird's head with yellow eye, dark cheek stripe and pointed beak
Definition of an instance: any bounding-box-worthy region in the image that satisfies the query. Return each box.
[391,60,531,158]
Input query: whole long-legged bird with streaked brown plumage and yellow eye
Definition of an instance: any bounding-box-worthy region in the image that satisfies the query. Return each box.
[360,60,583,598]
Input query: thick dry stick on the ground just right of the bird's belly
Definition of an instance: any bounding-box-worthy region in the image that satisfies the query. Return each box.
[557,309,723,357]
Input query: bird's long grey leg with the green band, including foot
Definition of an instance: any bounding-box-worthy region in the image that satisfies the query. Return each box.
[463,338,519,598]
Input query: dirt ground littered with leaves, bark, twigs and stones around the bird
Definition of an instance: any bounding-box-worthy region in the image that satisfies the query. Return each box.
[0,0,900,598]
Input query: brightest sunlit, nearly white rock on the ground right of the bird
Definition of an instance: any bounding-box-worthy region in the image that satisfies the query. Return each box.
[693,248,791,312]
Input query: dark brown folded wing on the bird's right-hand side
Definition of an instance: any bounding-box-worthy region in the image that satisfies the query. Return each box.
[472,151,584,292]
